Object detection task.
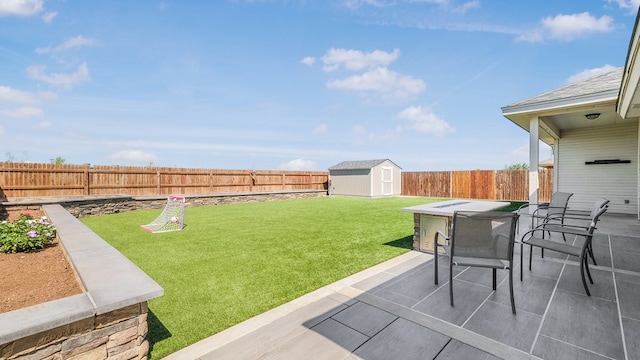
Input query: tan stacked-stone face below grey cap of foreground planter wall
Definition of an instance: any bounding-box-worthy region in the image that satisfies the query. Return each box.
[0,302,149,360]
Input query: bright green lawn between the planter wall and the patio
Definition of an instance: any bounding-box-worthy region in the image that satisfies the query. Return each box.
[81,197,444,359]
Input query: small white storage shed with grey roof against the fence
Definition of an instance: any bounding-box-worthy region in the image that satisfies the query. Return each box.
[329,159,402,197]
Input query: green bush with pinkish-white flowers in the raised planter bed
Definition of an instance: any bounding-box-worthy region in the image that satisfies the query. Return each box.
[0,213,56,253]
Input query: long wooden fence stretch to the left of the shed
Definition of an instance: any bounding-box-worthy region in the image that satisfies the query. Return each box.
[0,163,329,200]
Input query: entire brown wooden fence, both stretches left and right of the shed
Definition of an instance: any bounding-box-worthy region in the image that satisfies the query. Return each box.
[0,162,553,201]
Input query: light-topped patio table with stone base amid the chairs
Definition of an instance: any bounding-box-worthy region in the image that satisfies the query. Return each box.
[402,199,511,253]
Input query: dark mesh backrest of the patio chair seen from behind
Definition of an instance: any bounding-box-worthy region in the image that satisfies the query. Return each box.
[449,211,518,261]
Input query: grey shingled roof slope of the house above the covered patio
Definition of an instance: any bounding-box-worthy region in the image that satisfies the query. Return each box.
[502,67,624,112]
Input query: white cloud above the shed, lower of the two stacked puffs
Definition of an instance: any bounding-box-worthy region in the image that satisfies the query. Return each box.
[327,67,426,100]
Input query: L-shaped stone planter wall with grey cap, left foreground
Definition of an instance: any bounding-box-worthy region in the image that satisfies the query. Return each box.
[0,204,164,360]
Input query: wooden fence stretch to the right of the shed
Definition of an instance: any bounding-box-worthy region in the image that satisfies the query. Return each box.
[402,169,553,201]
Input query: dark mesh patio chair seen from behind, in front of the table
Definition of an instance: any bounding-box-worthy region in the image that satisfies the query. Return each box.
[433,211,518,314]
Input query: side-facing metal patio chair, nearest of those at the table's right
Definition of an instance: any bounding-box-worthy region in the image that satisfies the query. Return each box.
[520,200,608,296]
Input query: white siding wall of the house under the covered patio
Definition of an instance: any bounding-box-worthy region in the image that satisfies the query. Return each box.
[556,123,639,214]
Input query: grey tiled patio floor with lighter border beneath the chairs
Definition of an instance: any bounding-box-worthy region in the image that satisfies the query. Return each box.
[166,214,640,360]
